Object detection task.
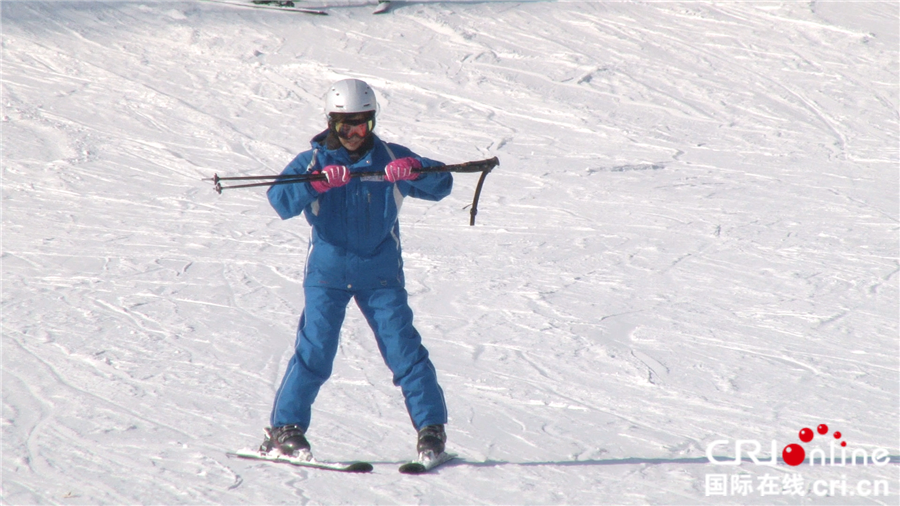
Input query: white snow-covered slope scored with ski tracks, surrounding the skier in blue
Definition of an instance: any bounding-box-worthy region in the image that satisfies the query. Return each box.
[0,1,900,504]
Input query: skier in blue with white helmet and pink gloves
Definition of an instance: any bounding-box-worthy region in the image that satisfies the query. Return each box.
[260,79,453,460]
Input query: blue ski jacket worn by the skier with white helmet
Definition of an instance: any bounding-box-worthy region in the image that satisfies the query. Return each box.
[267,131,453,291]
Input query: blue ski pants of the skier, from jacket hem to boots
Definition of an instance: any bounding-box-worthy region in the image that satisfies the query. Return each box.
[270,287,447,431]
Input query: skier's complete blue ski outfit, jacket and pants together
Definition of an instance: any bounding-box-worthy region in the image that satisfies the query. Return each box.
[268,131,453,431]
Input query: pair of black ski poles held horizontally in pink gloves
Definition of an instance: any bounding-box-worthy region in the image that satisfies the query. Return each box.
[212,156,500,225]
